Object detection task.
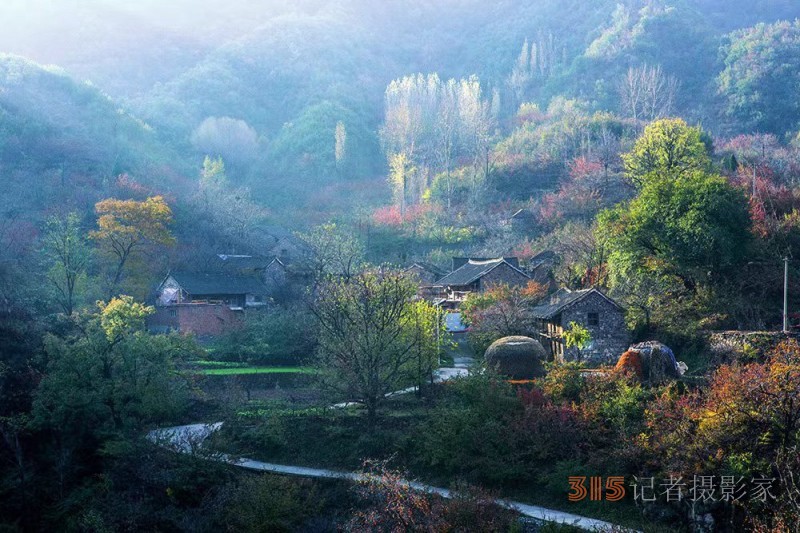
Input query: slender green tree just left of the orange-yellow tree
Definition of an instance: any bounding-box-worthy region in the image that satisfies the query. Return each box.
[42,212,89,315]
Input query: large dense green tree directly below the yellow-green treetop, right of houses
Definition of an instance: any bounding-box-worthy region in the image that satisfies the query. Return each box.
[597,171,751,293]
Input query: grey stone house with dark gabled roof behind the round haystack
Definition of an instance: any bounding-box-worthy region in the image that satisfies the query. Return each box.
[533,288,630,364]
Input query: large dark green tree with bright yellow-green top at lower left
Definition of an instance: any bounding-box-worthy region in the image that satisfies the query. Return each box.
[32,297,196,497]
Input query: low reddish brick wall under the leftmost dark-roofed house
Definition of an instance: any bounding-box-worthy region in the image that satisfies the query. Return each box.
[147,304,244,337]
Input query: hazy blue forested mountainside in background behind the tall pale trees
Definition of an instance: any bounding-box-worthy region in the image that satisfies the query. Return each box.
[3,0,796,222]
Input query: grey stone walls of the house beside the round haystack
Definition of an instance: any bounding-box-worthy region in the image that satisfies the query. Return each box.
[561,293,631,364]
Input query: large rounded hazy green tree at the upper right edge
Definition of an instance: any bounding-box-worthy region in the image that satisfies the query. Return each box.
[717,20,800,135]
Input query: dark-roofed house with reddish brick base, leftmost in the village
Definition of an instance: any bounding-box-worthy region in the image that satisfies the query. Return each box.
[148,254,287,337]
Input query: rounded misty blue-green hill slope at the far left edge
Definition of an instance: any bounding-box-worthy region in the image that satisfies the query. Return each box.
[0,55,192,218]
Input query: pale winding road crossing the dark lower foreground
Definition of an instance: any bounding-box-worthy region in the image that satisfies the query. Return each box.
[147,422,630,531]
